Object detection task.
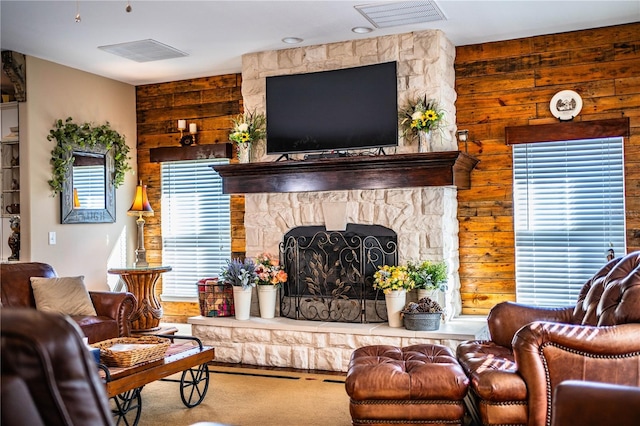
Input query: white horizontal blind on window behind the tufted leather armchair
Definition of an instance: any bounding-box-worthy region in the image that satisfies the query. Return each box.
[513,138,625,307]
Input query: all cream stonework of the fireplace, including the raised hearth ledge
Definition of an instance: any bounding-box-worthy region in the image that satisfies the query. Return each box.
[189,30,473,371]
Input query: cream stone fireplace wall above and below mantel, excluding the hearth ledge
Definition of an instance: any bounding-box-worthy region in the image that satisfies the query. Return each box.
[242,30,461,318]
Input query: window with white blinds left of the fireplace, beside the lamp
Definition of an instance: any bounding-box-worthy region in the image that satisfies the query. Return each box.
[162,160,231,300]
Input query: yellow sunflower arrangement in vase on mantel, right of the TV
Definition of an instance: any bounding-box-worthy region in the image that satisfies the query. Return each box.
[400,95,444,152]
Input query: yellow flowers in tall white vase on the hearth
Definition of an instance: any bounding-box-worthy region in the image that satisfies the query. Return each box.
[373,265,415,327]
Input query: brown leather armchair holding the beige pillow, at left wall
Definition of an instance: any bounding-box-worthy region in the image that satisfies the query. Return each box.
[0,262,136,343]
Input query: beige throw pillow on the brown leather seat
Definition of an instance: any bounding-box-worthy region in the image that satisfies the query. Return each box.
[31,276,97,316]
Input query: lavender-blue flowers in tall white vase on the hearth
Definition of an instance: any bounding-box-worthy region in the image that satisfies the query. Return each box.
[220,258,257,320]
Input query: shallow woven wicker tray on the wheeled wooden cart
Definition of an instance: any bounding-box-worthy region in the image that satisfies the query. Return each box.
[91,336,171,367]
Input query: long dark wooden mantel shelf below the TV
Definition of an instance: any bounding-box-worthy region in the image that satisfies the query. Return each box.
[212,151,478,194]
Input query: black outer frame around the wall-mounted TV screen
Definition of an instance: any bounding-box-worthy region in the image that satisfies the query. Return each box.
[265,61,399,155]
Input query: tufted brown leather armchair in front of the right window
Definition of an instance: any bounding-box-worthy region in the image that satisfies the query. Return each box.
[457,252,640,426]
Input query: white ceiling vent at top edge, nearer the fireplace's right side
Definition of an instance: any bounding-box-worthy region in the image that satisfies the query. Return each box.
[355,1,447,28]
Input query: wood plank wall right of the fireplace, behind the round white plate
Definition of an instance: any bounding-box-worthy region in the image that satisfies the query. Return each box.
[455,23,640,314]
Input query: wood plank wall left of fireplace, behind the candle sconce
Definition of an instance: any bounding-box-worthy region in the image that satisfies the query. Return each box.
[136,74,245,322]
